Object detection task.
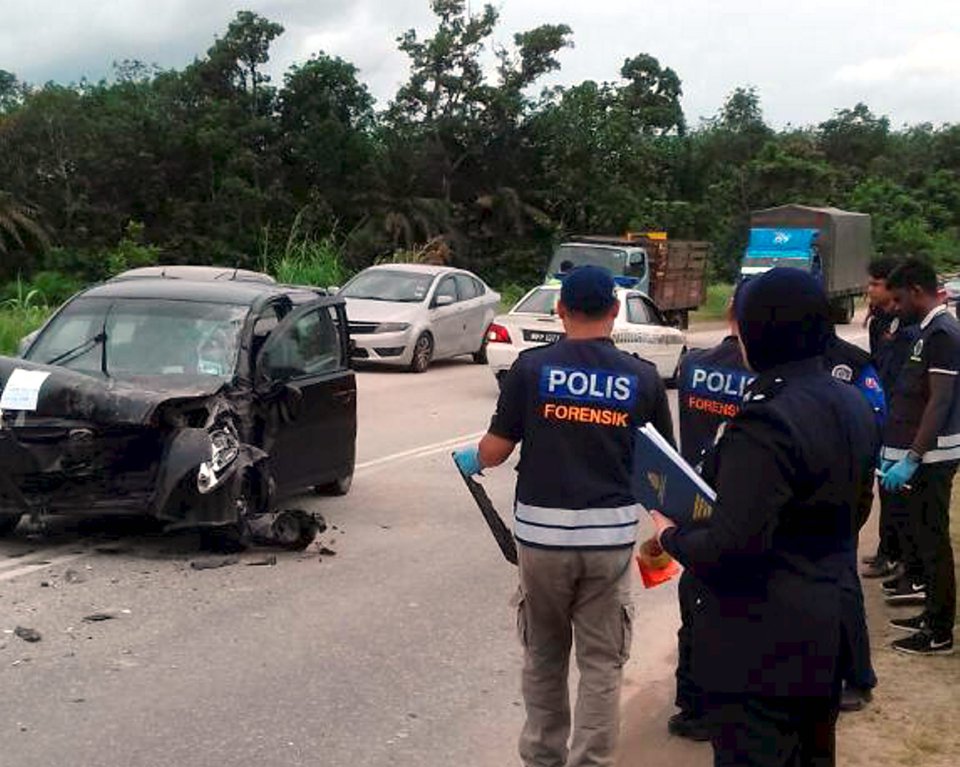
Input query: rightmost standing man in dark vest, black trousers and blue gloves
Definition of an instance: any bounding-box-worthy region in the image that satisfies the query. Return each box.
[881,259,960,655]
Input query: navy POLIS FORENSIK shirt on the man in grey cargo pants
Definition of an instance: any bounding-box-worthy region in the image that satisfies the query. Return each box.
[490,339,673,548]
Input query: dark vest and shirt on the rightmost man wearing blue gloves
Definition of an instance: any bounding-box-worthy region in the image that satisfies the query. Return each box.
[883,306,960,463]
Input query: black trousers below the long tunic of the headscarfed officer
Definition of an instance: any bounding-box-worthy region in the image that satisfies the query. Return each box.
[710,696,839,767]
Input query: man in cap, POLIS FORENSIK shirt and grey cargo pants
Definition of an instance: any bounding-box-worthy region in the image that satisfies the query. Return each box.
[455,266,673,767]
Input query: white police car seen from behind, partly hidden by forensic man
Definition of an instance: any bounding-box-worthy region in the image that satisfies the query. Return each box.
[487,281,686,382]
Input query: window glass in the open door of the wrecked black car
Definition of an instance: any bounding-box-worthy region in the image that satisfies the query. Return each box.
[263,308,343,381]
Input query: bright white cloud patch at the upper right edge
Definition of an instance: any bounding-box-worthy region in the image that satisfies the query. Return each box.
[835,32,960,85]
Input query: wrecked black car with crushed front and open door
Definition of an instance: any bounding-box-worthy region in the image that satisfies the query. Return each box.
[0,270,357,548]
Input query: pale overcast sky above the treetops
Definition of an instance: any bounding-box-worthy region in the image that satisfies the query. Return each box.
[0,0,960,127]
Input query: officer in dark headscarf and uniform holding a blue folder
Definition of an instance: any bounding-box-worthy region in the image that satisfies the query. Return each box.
[652,268,877,767]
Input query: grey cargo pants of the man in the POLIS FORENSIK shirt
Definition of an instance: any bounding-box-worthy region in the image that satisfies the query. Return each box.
[517,545,633,767]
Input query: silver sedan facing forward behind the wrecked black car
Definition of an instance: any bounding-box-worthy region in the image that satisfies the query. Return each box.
[340,264,500,373]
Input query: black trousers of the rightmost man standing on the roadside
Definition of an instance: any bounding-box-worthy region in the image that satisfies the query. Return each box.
[900,463,957,637]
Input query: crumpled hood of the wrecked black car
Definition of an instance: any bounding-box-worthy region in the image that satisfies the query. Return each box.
[0,357,225,425]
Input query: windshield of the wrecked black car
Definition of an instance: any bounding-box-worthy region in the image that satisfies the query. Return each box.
[26,298,248,378]
